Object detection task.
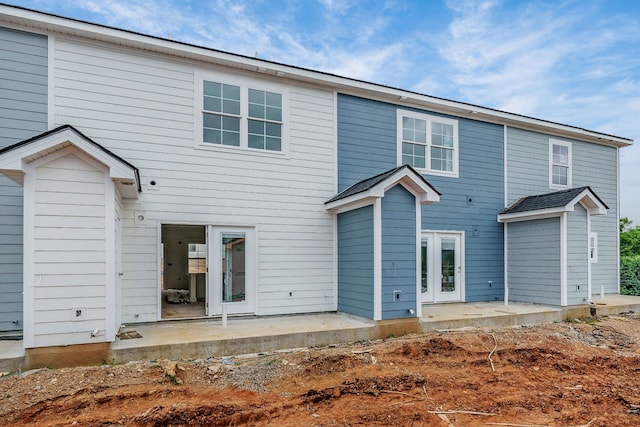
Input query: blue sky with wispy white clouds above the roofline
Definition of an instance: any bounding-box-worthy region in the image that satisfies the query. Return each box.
[5,0,640,225]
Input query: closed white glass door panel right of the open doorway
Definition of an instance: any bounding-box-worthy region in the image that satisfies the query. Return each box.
[207,226,256,316]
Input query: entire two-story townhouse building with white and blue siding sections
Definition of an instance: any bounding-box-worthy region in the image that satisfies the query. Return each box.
[0,5,632,348]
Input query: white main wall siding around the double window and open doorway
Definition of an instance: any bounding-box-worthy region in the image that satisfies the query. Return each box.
[54,37,336,323]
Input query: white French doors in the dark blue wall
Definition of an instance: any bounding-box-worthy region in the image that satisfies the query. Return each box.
[420,231,464,303]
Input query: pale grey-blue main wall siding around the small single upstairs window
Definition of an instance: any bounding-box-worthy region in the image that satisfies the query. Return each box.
[507,128,618,294]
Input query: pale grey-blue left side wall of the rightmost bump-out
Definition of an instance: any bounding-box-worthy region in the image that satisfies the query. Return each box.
[507,218,560,305]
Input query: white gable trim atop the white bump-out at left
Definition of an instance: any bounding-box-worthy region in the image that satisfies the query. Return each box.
[0,128,138,199]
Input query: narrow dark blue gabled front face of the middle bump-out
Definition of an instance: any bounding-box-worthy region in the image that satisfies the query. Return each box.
[382,185,416,320]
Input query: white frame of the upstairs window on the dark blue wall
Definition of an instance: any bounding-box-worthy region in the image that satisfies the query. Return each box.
[396,109,459,178]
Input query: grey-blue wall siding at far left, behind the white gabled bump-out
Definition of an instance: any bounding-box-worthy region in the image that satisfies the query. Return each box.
[0,28,47,331]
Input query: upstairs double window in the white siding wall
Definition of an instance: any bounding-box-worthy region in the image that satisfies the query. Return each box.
[196,72,286,152]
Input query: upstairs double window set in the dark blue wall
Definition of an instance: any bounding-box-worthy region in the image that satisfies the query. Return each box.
[398,110,458,177]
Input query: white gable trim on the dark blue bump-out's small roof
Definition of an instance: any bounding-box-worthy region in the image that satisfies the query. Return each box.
[325,168,440,213]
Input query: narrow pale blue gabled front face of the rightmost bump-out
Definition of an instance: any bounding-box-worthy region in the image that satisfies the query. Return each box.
[567,204,589,305]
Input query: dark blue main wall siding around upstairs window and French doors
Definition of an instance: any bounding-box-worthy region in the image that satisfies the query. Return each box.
[338,95,504,301]
